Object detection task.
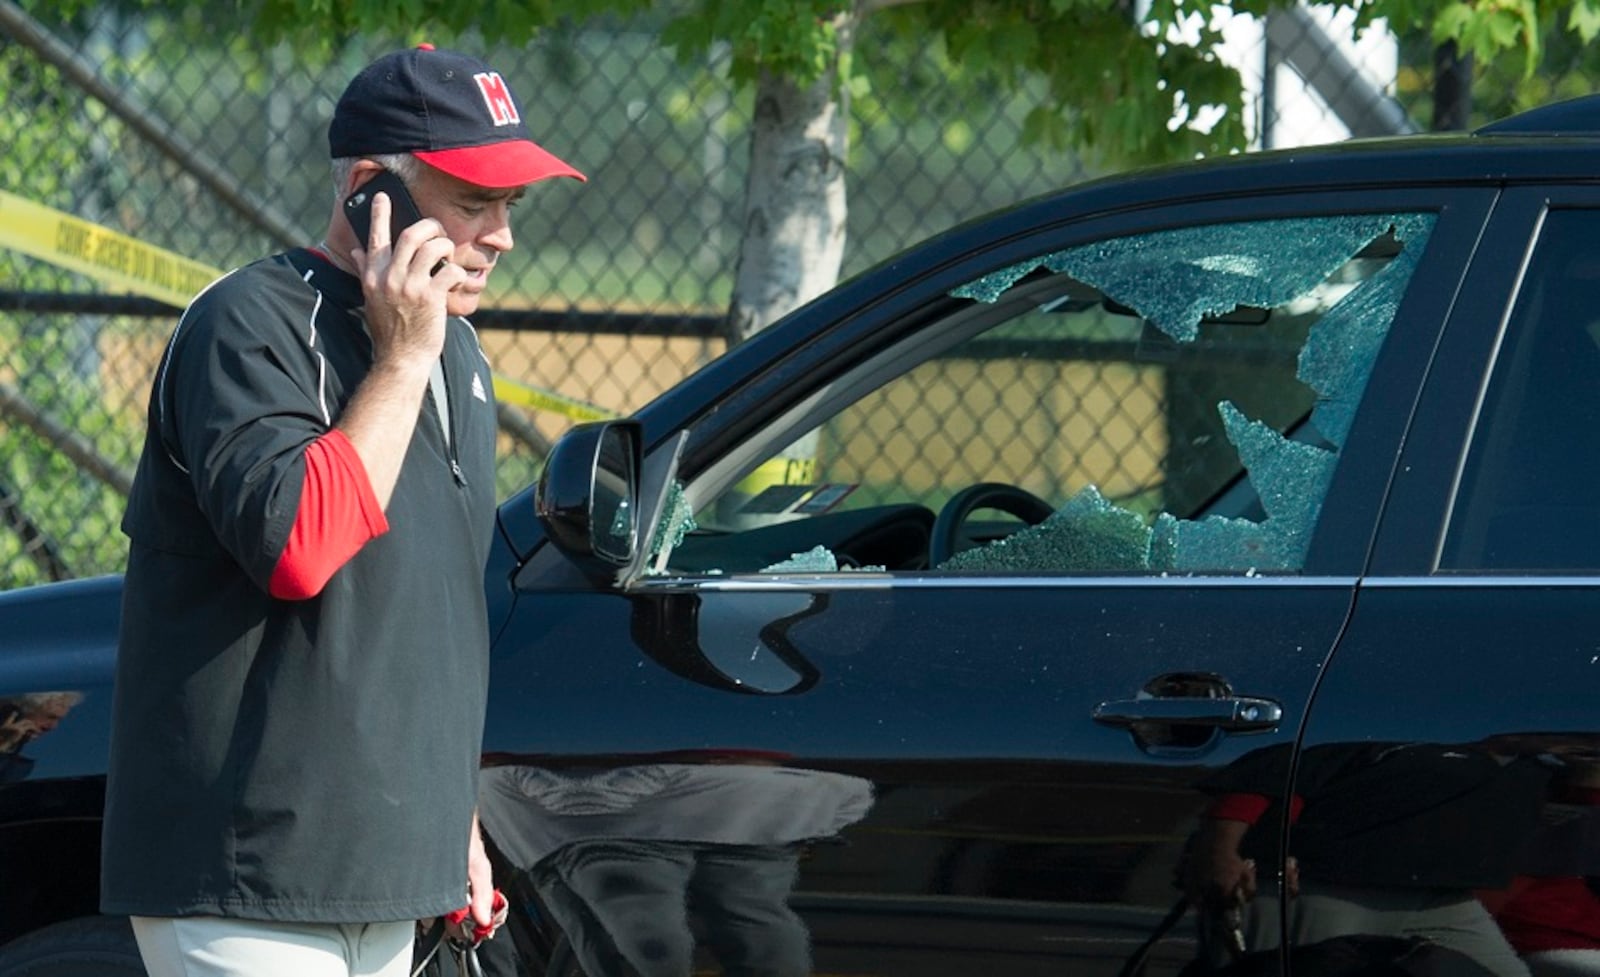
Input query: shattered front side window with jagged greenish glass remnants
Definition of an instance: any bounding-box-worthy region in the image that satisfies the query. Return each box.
[662,214,1434,574]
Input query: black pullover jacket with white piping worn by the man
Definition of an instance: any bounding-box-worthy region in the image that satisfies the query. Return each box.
[101,251,496,923]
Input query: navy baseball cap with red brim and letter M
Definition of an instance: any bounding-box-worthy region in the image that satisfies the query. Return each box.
[328,45,587,187]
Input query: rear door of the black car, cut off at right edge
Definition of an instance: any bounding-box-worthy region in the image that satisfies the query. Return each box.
[1290,187,1600,974]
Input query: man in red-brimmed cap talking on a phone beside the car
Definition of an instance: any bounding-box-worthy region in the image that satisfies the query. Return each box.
[101,45,582,977]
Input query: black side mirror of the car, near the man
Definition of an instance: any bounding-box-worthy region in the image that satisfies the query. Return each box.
[533,421,643,579]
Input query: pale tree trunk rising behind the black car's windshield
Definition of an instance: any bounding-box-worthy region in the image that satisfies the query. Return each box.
[728,20,850,342]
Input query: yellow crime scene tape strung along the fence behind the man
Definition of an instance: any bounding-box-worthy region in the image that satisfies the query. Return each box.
[0,190,616,421]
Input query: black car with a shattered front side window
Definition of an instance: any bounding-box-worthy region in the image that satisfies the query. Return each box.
[0,98,1600,977]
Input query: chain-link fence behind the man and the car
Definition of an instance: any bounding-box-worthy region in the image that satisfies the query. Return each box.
[0,0,1589,588]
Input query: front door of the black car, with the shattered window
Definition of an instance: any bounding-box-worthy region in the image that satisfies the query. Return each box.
[480,189,1493,977]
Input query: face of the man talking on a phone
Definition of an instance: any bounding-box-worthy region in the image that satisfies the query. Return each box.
[411,165,525,315]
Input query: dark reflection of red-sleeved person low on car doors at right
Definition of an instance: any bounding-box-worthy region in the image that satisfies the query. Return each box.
[1184,740,1552,977]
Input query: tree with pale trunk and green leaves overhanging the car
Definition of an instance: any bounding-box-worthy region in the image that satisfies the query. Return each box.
[35,0,1600,348]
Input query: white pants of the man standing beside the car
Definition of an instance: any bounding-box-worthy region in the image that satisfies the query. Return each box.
[133,916,416,977]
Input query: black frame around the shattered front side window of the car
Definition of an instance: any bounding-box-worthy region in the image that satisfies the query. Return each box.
[515,184,1494,590]
